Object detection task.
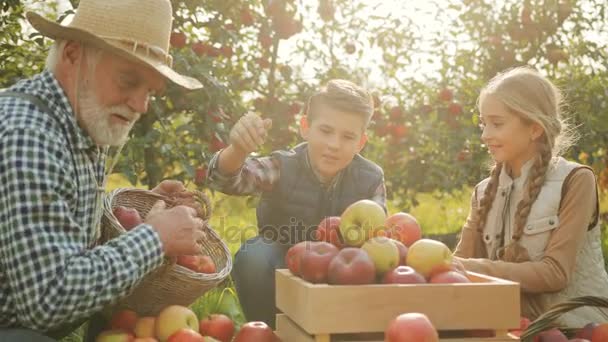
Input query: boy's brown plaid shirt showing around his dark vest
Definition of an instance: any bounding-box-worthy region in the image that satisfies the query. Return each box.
[207,147,386,208]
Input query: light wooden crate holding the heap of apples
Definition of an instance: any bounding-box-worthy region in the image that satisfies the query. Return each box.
[276,269,520,342]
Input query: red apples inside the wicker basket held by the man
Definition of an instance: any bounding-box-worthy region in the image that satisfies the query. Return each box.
[112,206,217,274]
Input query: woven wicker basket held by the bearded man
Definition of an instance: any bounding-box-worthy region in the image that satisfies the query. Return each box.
[100,188,232,316]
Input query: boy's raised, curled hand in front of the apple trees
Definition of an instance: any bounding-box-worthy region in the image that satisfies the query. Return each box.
[230,113,272,154]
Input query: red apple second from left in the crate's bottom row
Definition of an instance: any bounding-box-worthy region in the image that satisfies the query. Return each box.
[300,241,339,284]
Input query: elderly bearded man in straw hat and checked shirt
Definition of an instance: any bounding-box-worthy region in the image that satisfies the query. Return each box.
[0,0,203,341]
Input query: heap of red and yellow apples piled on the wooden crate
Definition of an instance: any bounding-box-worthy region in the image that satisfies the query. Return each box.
[285,200,470,285]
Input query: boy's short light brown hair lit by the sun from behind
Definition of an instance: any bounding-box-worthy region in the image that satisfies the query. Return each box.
[305,79,374,127]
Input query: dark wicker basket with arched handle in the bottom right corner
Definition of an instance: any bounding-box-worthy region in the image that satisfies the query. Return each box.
[521,296,608,342]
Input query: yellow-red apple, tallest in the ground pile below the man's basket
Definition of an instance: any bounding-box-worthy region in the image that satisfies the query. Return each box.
[155,305,199,341]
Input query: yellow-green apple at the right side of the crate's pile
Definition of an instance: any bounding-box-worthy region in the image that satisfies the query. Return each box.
[407,239,452,278]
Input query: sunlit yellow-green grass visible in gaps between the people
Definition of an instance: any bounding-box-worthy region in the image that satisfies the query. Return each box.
[62,176,608,342]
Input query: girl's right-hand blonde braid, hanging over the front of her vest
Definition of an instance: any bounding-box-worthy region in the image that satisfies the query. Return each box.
[512,142,553,241]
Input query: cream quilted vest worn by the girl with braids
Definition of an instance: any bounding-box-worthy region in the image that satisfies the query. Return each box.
[477,158,608,327]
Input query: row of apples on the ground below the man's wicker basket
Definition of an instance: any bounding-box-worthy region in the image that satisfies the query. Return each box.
[96,305,279,342]
